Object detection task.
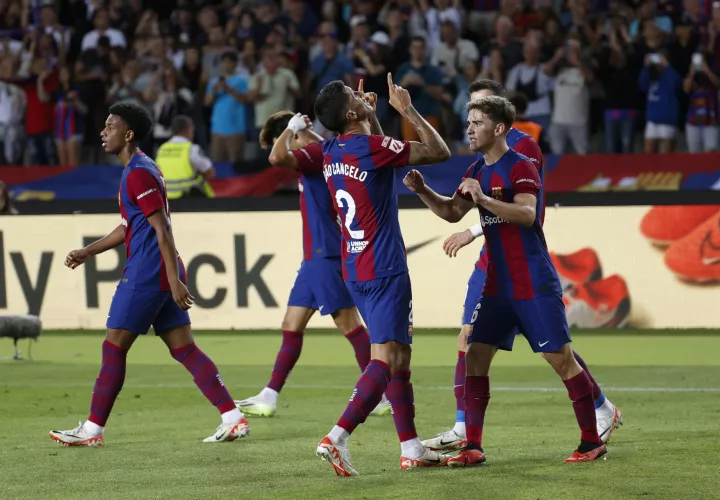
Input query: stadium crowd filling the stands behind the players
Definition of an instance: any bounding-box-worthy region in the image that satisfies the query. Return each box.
[0,0,720,166]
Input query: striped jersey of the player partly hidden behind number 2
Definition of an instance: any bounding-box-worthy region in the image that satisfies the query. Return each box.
[291,142,340,260]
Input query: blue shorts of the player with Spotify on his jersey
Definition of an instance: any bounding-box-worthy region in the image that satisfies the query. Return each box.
[468,295,571,352]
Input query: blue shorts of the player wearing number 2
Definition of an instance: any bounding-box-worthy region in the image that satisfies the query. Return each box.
[347,271,412,344]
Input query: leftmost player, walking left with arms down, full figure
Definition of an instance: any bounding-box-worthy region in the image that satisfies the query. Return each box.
[50,103,250,446]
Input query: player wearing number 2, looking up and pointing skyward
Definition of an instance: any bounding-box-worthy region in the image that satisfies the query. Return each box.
[315,74,450,476]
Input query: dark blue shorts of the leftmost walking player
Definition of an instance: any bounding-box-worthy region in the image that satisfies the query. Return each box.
[107,287,190,335]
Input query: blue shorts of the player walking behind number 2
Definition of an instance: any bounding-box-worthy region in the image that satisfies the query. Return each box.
[288,258,355,316]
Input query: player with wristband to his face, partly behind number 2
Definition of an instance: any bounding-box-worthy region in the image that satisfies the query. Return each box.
[235,111,390,416]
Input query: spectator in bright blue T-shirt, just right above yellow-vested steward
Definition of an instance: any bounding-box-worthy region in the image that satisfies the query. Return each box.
[205,52,248,162]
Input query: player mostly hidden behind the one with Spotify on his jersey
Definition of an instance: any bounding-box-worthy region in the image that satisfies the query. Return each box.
[423,79,623,450]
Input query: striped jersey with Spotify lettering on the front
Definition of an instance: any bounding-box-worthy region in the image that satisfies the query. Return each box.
[459,149,562,300]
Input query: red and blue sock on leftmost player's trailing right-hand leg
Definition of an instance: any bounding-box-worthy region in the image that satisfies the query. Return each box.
[170,342,236,414]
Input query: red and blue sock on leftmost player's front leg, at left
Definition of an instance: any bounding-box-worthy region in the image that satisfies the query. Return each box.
[88,340,127,427]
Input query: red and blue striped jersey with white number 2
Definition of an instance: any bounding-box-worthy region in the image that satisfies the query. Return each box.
[323,134,410,281]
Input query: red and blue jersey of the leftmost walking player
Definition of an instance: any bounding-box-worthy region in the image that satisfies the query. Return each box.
[118,152,187,291]
